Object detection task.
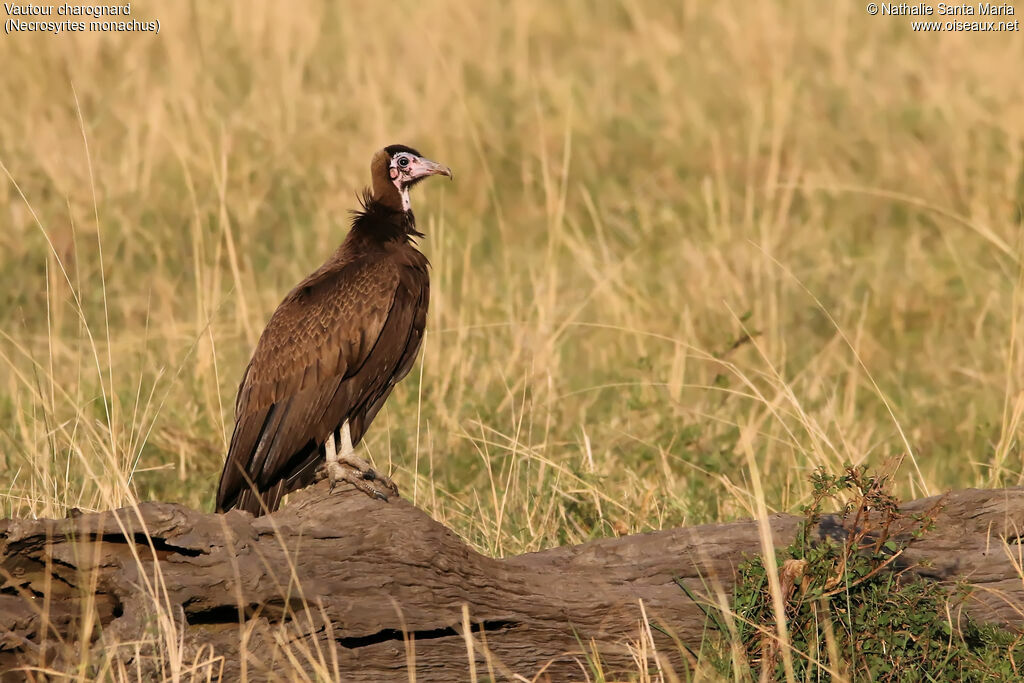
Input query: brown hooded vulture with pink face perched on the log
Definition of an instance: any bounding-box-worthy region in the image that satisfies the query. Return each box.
[217,144,452,515]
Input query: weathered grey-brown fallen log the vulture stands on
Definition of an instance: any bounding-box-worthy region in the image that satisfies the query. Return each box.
[6,484,1024,681]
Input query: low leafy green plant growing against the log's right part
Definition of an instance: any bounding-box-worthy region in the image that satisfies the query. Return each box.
[701,465,1024,681]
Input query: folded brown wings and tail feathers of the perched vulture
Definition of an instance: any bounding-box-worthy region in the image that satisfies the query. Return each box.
[217,254,426,514]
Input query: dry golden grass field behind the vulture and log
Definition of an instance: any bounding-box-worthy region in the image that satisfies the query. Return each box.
[0,0,1024,573]
